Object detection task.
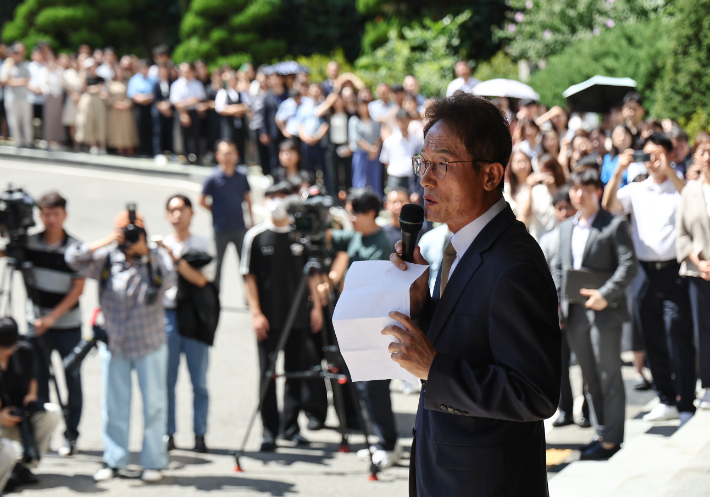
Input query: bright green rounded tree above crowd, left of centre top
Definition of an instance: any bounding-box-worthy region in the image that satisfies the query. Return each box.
[174,0,287,67]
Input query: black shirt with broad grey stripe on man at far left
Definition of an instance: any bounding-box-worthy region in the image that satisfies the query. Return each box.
[25,232,81,330]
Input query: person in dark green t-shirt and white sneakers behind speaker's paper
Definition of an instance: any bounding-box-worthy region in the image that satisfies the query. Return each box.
[328,188,402,469]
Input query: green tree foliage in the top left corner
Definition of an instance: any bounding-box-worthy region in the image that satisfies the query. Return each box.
[2,0,180,55]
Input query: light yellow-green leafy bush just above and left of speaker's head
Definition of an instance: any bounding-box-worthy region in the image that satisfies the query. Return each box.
[355,11,471,96]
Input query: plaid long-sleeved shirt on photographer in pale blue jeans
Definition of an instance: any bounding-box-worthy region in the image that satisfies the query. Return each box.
[66,243,177,359]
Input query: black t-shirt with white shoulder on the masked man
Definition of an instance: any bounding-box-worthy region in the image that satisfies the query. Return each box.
[241,223,310,336]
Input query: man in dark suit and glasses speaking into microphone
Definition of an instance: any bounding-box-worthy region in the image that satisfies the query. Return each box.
[382,94,561,497]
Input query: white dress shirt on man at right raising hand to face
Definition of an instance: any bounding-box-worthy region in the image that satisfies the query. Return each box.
[617,178,680,262]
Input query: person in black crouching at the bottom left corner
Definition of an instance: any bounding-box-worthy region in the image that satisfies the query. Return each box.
[0,317,60,490]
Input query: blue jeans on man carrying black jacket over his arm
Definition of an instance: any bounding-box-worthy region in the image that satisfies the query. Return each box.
[165,309,210,435]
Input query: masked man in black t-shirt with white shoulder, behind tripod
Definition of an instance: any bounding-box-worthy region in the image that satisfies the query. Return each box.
[240,182,323,452]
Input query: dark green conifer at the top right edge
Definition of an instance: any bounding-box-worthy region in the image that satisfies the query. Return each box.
[656,0,710,119]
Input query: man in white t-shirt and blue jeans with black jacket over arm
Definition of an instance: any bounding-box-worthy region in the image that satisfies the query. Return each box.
[158,194,210,453]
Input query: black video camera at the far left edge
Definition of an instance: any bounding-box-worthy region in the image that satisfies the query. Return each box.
[0,183,35,261]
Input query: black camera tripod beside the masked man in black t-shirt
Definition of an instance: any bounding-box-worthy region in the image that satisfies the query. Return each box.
[234,242,378,480]
